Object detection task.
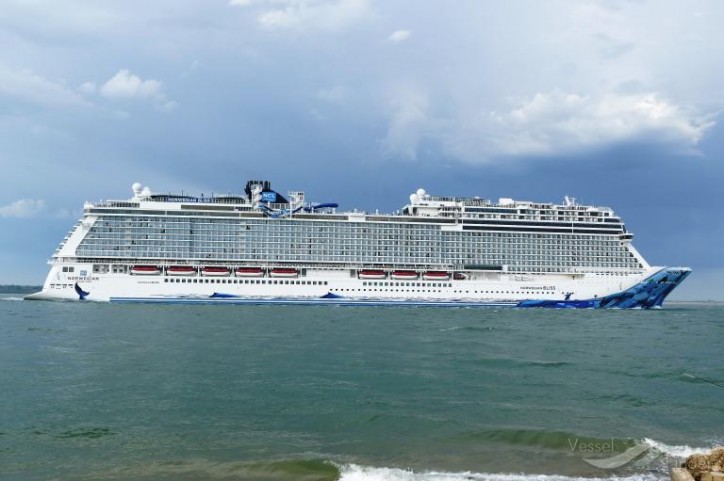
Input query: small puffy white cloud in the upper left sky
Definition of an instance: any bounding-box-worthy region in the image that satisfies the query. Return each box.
[96,69,178,111]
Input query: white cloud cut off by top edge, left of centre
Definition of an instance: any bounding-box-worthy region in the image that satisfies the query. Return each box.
[229,0,371,31]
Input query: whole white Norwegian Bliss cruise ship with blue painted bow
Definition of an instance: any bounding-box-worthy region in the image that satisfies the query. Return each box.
[27,180,691,309]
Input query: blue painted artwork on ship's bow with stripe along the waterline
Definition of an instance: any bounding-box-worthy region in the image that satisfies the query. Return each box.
[110,267,691,309]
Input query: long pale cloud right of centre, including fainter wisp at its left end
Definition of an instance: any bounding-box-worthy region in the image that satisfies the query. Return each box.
[383,91,715,163]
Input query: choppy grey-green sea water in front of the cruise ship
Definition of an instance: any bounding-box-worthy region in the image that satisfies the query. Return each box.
[0,295,724,481]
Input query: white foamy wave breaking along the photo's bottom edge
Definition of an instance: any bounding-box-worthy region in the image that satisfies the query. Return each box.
[339,464,668,481]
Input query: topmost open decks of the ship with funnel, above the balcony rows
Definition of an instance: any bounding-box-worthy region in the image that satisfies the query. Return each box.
[84,181,625,231]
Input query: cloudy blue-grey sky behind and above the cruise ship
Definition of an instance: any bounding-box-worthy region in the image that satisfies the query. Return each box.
[0,0,724,300]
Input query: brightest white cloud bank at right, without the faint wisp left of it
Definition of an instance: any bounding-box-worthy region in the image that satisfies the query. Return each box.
[481,91,714,155]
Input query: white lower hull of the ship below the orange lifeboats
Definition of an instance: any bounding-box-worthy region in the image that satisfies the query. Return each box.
[28,264,662,304]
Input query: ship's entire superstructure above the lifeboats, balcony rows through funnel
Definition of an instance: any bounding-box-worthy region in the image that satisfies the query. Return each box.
[54,183,646,272]
